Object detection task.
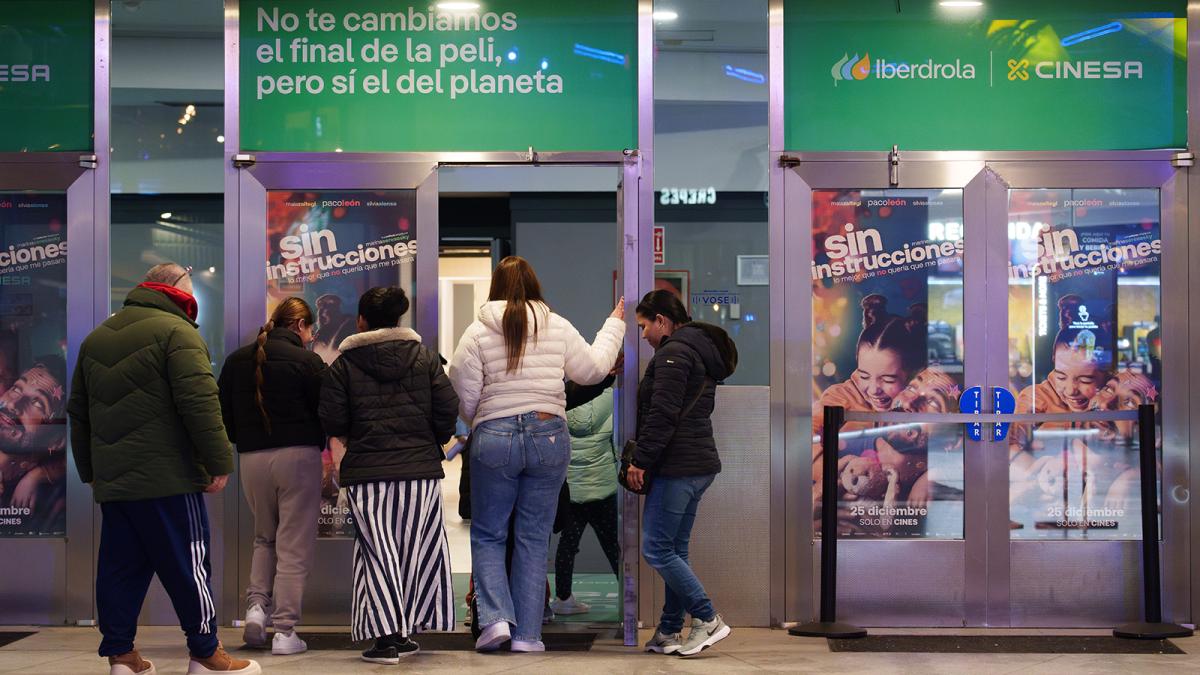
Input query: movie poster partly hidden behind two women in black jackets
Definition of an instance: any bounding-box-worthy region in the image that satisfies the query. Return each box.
[266,190,416,538]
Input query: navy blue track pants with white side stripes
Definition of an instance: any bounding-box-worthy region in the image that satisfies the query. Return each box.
[96,494,217,658]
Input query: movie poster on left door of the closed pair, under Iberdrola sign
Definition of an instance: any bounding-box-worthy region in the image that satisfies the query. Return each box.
[811,190,962,538]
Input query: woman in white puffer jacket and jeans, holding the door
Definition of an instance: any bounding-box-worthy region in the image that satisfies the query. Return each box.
[450,256,625,652]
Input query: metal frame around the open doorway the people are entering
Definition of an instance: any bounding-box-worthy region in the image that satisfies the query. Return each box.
[222,153,641,625]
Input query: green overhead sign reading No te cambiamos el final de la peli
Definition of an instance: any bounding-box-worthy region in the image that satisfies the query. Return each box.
[239,0,637,153]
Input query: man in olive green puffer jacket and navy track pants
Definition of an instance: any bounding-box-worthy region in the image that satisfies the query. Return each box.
[67,263,260,675]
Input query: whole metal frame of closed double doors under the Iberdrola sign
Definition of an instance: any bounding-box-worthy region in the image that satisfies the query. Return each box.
[772,150,1193,626]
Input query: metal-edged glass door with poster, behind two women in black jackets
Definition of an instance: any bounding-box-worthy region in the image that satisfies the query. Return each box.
[231,155,439,625]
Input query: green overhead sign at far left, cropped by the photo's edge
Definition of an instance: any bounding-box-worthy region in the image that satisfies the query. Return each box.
[0,0,95,153]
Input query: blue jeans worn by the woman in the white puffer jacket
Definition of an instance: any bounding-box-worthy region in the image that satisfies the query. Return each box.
[470,413,571,641]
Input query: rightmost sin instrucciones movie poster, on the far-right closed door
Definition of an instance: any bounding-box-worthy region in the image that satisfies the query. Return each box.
[1008,190,1163,540]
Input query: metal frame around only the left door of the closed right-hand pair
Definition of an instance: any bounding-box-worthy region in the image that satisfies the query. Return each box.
[772,154,986,627]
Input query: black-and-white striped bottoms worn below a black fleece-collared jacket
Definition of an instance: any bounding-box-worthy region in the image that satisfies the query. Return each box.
[348,479,454,640]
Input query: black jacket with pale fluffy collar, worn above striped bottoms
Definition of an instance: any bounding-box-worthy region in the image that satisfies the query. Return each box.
[320,328,458,485]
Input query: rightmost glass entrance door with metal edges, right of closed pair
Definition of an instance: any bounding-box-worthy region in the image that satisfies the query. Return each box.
[986,159,1188,627]
